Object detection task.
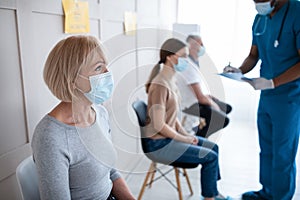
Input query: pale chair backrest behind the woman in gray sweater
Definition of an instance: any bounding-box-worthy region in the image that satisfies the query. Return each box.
[16,156,40,200]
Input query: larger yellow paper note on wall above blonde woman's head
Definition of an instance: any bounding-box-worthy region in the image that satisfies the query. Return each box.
[62,0,90,33]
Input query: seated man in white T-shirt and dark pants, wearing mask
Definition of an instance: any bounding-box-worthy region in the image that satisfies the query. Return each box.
[177,35,232,137]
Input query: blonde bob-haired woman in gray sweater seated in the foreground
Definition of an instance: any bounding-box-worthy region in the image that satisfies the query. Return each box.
[32,36,134,200]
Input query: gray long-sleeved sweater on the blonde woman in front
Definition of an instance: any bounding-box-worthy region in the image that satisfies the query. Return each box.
[31,106,120,200]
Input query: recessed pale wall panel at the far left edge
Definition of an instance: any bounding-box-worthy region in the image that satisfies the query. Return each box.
[0,9,28,155]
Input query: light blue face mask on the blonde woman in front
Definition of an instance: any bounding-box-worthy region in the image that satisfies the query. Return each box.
[84,72,114,104]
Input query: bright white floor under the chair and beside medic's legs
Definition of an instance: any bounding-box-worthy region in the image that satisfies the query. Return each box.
[126,121,300,200]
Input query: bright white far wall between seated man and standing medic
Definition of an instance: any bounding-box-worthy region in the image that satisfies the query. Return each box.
[178,0,259,123]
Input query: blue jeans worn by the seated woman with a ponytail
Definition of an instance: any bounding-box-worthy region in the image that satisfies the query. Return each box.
[144,137,220,197]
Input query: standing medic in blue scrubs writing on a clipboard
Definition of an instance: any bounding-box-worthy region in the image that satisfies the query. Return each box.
[224,0,300,200]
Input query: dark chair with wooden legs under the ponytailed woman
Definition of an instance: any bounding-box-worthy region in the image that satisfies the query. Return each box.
[132,100,198,200]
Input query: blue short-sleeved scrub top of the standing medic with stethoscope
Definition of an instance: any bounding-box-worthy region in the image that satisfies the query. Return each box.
[252,1,300,102]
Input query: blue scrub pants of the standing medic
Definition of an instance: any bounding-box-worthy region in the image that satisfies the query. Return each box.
[257,95,300,200]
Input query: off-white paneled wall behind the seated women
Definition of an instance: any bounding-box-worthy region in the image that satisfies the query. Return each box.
[0,0,177,200]
